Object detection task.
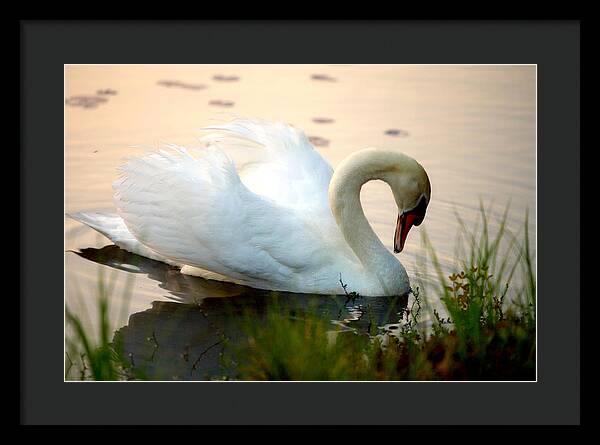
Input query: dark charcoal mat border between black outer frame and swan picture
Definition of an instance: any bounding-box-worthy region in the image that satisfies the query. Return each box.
[20,21,581,425]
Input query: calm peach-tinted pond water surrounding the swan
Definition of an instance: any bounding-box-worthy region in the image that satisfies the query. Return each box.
[65,65,536,379]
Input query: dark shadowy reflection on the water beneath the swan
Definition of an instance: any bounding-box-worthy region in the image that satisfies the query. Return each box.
[69,245,408,380]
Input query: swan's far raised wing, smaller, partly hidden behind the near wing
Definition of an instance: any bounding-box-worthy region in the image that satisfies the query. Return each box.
[202,118,333,218]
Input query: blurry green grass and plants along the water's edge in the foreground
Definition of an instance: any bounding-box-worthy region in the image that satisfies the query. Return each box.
[66,205,536,381]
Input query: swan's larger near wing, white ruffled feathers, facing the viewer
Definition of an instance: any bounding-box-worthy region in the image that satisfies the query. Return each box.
[113,145,330,287]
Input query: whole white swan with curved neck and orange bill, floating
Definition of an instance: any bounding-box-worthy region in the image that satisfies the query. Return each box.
[69,119,431,296]
